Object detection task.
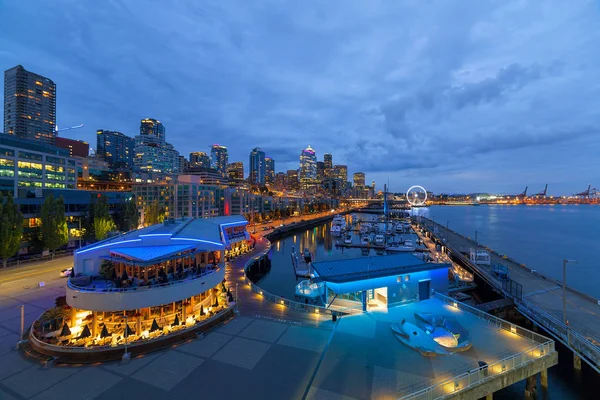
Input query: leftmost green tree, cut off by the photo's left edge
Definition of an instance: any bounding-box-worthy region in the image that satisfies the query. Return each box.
[0,194,23,268]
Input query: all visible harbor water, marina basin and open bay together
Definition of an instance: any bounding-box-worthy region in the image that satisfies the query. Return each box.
[259,205,600,400]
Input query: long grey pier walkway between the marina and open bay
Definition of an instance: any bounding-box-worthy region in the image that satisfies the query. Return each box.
[420,218,600,372]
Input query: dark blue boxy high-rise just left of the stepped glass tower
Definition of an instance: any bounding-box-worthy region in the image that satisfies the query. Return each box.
[96,129,135,169]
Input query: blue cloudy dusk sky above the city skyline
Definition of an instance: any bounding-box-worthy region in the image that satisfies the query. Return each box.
[0,0,600,194]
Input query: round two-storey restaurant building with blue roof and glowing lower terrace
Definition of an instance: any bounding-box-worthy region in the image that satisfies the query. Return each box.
[29,216,250,362]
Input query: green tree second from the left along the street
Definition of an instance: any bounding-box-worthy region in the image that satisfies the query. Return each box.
[40,193,69,258]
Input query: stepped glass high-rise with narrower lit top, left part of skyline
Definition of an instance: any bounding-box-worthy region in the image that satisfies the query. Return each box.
[133,118,180,178]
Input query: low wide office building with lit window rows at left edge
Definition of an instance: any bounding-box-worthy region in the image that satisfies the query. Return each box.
[0,134,77,197]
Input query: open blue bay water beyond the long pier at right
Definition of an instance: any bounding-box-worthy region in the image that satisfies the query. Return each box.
[414,205,600,299]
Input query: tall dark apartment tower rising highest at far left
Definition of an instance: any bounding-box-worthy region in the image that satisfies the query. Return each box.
[4,65,56,144]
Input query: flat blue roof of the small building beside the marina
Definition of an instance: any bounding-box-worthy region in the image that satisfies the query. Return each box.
[312,253,450,283]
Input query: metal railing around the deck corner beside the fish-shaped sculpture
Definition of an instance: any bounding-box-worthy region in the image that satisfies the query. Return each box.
[400,293,555,400]
